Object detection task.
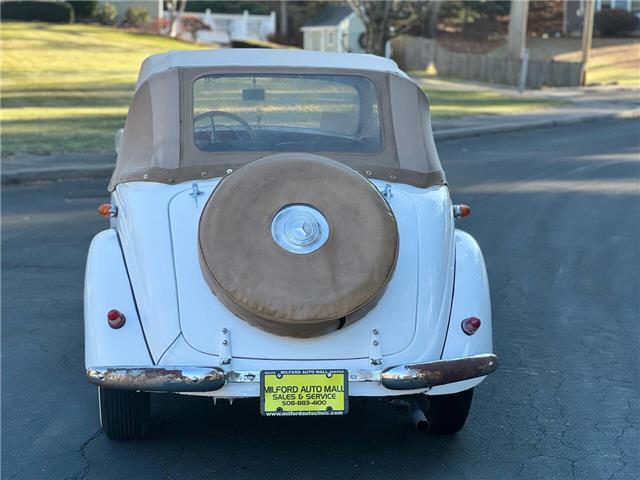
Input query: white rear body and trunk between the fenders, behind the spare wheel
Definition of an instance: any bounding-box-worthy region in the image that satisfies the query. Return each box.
[114,180,453,360]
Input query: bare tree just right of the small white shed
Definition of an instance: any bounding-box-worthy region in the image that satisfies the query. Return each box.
[347,0,441,56]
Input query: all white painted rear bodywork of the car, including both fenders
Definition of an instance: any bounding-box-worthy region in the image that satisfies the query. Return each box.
[85,180,492,397]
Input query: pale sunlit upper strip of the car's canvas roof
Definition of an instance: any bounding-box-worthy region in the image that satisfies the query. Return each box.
[137,48,408,87]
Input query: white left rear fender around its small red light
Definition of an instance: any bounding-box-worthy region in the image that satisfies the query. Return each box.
[84,229,153,368]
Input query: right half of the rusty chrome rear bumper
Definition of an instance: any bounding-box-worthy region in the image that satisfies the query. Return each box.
[382,353,498,390]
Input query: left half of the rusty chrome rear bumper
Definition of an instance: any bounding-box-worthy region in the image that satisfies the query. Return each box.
[86,367,225,392]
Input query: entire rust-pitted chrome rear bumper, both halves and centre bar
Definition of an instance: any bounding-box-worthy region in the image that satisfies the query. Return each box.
[87,354,498,392]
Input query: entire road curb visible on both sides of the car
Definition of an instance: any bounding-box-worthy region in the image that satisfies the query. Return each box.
[1,108,640,185]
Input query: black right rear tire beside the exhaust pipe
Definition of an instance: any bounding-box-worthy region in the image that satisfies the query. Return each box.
[418,388,473,435]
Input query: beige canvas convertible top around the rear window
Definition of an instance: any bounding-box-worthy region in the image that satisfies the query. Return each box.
[109,49,445,190]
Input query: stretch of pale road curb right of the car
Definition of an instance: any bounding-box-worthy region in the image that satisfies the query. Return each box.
[433,108,640,140]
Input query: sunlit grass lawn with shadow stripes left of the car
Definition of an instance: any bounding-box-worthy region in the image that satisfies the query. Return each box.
[0,22,208,156]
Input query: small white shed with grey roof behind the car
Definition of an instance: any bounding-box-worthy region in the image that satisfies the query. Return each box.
[300,5,365,53]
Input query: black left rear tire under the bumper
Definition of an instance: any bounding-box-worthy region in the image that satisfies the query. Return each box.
[98,387,151,440]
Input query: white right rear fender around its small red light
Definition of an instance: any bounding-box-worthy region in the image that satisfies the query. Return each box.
[429,230,493,395]
